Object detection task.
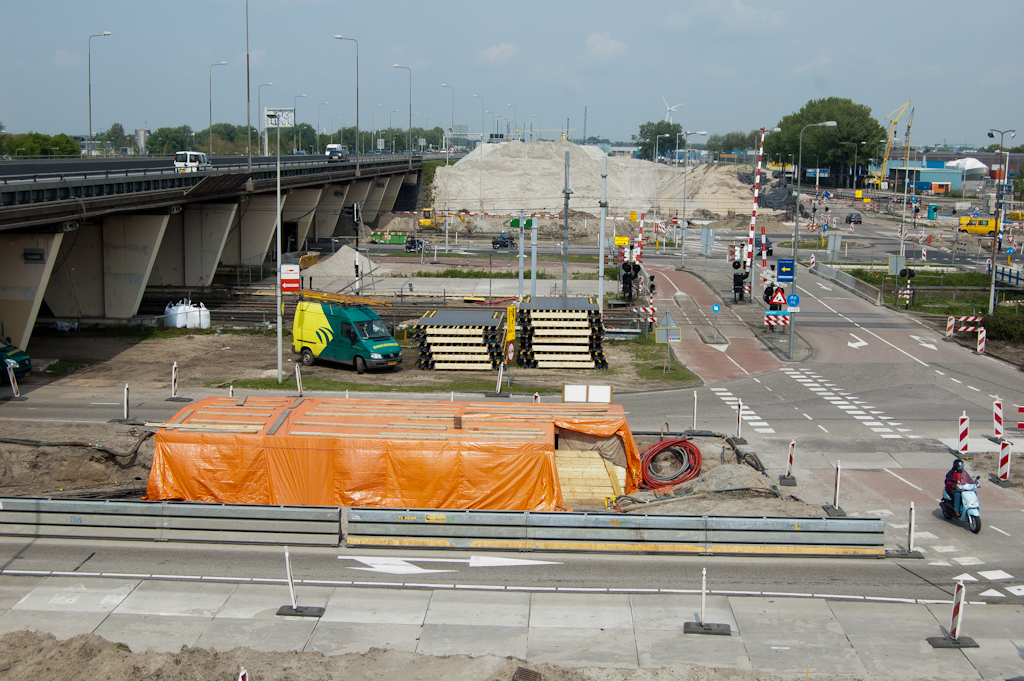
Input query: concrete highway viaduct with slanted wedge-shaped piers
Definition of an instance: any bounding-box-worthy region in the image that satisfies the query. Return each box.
[0,156,421,348]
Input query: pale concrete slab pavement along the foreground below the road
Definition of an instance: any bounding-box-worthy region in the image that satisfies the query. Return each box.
[0,576,1024,679]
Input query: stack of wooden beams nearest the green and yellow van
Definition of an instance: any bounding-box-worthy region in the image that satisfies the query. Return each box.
[413,310,505,371]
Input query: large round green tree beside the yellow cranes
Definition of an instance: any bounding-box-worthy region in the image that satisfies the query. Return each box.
[765,97,887,179]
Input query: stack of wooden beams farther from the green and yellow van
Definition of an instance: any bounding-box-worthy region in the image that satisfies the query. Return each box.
[517,298,608,369]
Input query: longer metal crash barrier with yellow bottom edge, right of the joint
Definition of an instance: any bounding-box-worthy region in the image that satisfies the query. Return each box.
[345,508,885,558]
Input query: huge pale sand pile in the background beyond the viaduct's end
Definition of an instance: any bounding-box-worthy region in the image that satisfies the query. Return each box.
[433,140,773,216]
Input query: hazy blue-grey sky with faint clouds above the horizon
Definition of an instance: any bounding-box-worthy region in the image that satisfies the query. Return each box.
[0,0,1024,146]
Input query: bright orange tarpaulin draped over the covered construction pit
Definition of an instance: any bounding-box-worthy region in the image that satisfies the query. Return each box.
[146,397,639,510]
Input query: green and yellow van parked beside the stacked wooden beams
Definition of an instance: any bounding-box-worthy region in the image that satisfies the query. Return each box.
[292,291,401,374]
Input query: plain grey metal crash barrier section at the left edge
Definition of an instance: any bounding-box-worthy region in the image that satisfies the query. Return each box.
[0,498,341,546]
